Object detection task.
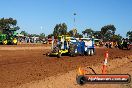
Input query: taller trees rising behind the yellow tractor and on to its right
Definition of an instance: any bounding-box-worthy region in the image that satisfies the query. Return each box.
[48,23,132,41]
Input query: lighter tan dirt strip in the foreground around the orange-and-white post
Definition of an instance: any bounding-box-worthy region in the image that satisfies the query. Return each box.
[15,56,132,88]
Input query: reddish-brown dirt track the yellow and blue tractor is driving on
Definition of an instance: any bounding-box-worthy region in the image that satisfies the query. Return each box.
[0,45,132,88]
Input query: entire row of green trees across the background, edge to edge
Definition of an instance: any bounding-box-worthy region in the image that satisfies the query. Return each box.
[0,18,132,41]
